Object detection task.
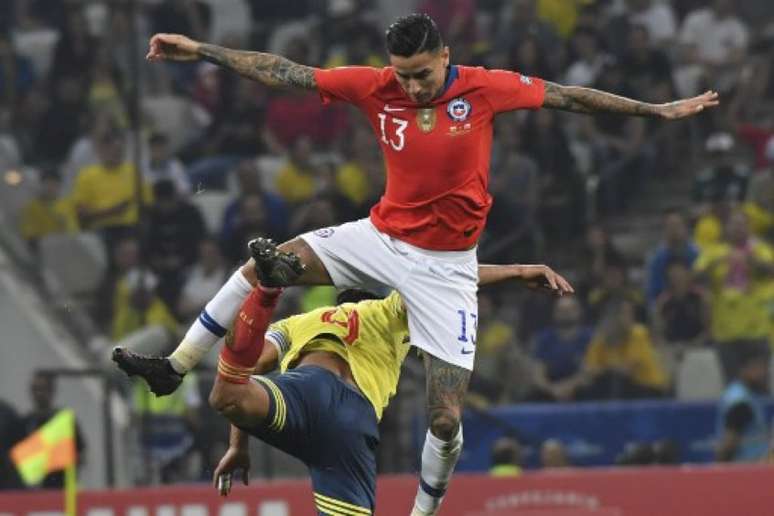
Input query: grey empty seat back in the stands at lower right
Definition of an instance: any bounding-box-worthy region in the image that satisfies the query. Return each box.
[676,349,723,400]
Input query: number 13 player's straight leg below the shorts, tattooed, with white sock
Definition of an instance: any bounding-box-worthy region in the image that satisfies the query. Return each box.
[412,353,471,516]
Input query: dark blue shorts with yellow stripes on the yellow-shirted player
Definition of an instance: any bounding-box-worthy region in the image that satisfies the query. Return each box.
[243,366,379,516]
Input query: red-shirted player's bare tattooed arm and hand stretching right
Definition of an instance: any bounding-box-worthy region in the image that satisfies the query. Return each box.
[543,81,720,120]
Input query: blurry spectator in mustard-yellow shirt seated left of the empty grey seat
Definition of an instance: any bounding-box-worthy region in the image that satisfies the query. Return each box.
[583,300,669,399]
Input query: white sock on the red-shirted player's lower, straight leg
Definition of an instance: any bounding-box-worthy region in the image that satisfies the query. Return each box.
[412,425,462,515]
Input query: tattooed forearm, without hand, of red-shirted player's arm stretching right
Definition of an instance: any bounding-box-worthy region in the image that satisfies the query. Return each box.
[543,81,660,117]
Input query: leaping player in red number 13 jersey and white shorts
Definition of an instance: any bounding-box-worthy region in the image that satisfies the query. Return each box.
[115,14,718,514]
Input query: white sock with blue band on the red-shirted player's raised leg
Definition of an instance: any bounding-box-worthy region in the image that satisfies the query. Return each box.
[169,270,253,374]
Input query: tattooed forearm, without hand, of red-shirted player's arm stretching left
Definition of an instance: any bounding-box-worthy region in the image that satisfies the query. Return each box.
[199,44,317,90]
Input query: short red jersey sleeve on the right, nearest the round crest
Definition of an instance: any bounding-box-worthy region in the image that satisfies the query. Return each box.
[484,70,546,113]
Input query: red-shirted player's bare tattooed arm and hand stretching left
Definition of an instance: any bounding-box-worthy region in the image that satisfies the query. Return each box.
[145,34,317,90]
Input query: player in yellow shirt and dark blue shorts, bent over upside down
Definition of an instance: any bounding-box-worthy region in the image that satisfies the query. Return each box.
[210,253,572,516]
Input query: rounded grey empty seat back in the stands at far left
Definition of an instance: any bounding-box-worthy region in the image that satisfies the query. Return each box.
[40,233,107,297]
